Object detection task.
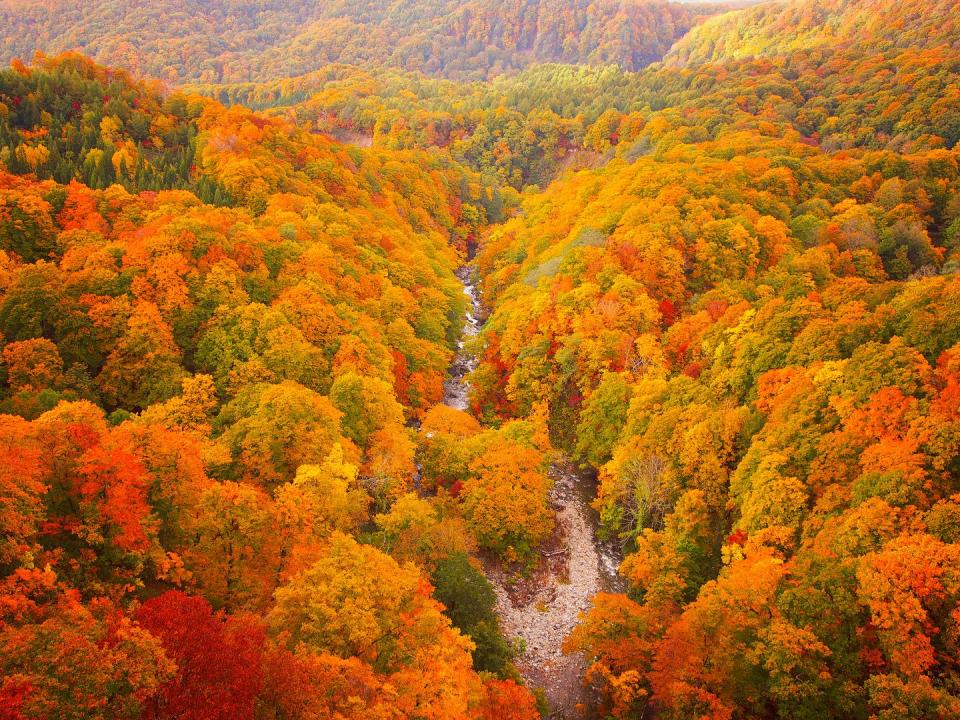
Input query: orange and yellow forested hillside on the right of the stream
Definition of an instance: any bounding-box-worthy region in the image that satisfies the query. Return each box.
[470,1,960,720]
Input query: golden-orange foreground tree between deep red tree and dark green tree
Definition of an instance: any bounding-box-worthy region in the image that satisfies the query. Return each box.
[267,533,479,720]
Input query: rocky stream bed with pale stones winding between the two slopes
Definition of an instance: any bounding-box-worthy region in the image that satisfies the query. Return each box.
[444,265,622,720]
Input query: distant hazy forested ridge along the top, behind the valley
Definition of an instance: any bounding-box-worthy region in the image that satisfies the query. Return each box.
[0,0,718,82]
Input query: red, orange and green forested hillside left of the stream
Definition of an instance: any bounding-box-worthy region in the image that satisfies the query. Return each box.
[0,55,539,720]
